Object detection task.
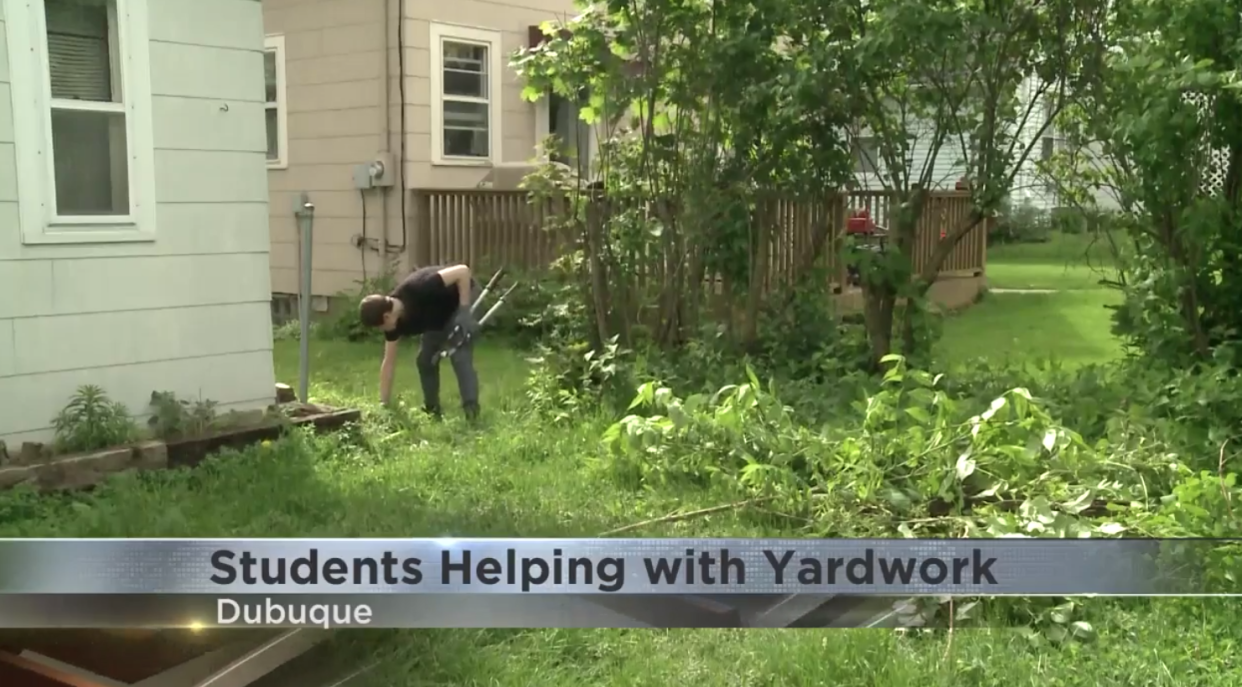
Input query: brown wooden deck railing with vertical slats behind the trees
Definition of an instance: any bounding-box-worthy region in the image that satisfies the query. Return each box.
[411,189,986,289]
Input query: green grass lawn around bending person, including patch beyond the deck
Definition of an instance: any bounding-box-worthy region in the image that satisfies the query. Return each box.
[0,234,1242,687]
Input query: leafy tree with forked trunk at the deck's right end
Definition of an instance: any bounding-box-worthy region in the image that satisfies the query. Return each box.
[807,0,1108,359]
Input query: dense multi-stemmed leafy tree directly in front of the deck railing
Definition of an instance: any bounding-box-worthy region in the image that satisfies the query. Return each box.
[514,0,850,345]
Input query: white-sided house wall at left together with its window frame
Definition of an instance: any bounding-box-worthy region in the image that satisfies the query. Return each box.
[0,0,273,441]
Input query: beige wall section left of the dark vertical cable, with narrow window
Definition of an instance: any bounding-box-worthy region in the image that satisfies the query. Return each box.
[263,0,401,296]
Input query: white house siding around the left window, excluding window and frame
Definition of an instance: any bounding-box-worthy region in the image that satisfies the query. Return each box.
[0,0,273,444]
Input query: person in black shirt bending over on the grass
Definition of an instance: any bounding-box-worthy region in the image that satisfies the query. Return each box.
[358,265,479,420]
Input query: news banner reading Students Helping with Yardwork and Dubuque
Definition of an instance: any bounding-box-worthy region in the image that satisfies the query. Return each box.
[0,539,1240,627]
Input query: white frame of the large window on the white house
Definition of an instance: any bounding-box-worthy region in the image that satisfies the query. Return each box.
[0,0,156,245]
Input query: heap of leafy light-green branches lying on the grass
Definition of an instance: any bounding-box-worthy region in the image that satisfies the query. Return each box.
[597,357,1242,601]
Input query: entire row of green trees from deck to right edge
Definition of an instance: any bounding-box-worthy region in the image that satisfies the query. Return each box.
[514,0,1242,363]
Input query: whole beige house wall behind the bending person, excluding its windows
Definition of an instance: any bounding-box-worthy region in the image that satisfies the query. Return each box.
[263,0,575,296]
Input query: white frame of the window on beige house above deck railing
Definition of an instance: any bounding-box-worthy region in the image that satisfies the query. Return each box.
[427,22,504,166]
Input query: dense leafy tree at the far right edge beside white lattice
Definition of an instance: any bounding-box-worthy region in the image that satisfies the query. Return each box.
[1049,0,1242,360]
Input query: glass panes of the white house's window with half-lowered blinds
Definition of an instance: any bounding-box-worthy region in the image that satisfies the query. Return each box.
[43,0,130,216]
